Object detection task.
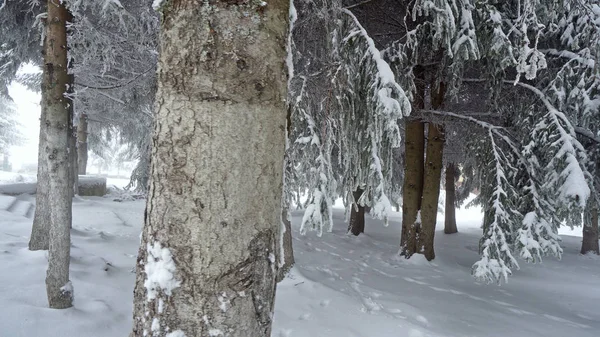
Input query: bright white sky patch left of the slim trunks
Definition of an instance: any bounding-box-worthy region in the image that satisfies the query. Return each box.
[8,82,41,171]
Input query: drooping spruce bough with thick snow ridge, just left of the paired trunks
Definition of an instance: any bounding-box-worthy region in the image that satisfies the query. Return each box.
[338,9,410,223]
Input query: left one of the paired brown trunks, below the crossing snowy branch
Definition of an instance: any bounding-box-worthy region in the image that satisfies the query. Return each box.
[400,121,425,258]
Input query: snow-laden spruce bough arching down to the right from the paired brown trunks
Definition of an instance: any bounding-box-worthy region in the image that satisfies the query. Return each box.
[420,104,562,282]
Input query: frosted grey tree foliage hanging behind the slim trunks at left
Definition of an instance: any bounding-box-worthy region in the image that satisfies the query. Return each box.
[5,0,158,190]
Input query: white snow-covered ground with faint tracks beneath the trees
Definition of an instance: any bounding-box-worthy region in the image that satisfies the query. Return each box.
[0,192,600,337]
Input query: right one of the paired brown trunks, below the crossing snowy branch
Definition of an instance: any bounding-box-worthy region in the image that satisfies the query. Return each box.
[417,123,445,261]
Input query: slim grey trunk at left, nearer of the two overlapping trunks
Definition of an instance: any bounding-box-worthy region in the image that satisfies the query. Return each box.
[37,0,73,309]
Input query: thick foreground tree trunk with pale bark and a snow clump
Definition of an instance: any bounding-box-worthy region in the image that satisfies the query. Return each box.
[132,0,289,337]
